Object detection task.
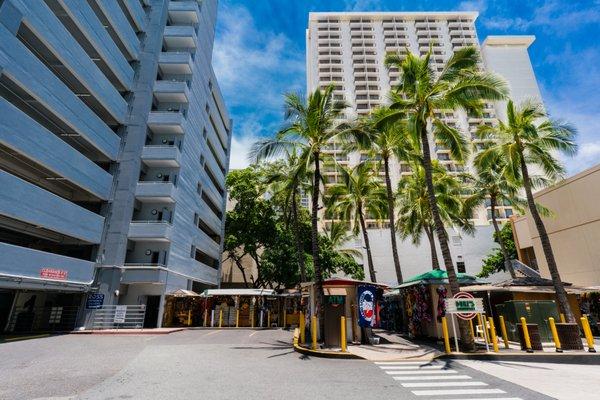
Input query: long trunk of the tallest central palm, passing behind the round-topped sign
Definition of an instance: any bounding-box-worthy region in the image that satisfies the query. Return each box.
[419,121,475,351]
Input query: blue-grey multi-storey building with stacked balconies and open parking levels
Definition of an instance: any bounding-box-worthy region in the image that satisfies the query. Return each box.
[0,0,232,331]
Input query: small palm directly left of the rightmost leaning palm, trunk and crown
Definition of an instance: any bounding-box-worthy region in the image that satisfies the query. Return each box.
[466,153,522,279]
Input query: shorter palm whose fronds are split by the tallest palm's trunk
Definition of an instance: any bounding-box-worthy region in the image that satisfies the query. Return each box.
[397,162,474,269]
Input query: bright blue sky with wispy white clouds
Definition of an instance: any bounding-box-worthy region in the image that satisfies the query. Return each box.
[213,0,600,174]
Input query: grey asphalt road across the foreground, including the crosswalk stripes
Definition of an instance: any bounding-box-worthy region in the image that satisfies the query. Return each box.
[0,330,564,400]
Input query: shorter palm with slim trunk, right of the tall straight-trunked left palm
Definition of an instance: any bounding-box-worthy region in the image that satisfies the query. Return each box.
[328,162,387,282]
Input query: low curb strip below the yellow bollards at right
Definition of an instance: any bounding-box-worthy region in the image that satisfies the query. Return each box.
[436,353,600,365]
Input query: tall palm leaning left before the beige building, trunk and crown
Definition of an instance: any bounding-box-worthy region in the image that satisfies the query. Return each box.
[476,101,577,322]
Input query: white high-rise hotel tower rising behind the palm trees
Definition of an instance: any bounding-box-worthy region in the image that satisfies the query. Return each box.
[306,12,541,283]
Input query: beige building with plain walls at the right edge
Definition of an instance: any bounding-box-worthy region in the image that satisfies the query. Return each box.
[512,164,600,286]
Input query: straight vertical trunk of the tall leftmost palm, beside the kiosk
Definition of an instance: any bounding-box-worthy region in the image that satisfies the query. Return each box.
[311,151,325,335]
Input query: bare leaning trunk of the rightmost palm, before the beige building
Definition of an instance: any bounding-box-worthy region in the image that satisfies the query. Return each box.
[521,151,576,323]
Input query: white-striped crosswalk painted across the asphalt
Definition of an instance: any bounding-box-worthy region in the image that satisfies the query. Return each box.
[375,361,522,400]
